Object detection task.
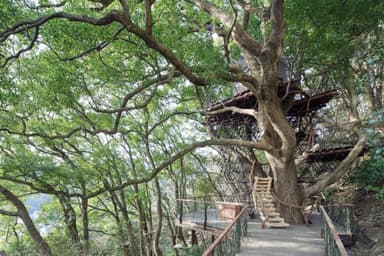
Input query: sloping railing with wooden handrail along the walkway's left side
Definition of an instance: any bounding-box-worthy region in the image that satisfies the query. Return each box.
[203,207,247,256]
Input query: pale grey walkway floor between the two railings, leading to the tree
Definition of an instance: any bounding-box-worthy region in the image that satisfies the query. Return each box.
[236,214,325,256]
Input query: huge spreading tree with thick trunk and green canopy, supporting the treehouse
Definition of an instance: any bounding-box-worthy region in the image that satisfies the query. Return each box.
[0,3,380,254]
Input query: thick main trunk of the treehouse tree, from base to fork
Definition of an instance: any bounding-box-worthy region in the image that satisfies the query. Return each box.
[258,77,304,223]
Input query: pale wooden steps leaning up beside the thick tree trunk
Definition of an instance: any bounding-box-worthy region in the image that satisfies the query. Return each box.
[253,176,289,228]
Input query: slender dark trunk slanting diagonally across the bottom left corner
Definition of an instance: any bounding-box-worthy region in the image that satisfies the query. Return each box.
[0,185,52,256]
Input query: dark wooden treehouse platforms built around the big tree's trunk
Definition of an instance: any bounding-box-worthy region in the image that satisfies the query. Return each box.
[205,80,366,182]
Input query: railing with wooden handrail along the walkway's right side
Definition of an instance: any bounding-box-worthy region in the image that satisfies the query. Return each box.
[320,206,348,256]
